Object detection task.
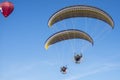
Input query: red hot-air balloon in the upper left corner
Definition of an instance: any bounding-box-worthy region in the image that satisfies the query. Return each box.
[0,1,14,17]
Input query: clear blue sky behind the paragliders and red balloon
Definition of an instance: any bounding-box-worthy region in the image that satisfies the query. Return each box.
[0,0,120,80]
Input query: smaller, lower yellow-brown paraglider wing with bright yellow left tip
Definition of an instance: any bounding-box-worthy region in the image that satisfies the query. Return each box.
[45,29,93,49]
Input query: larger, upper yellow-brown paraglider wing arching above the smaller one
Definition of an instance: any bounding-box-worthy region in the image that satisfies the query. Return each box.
[48,5,114,28]
